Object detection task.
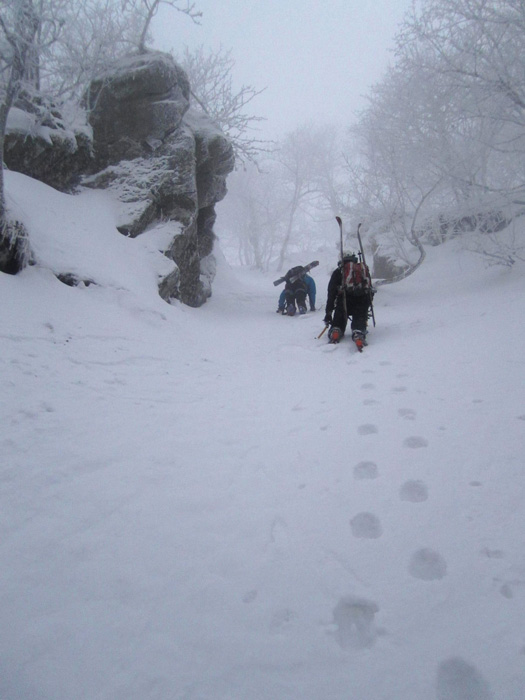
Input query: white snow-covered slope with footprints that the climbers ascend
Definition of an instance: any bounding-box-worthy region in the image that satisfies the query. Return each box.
[0,173,525,700]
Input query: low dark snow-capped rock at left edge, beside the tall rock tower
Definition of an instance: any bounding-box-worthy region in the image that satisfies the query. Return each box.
[4,90,93,192]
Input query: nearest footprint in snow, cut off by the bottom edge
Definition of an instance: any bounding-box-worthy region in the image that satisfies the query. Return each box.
[436,656,494,700]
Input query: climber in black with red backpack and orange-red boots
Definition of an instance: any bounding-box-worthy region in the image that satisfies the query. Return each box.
[324,251,375,351]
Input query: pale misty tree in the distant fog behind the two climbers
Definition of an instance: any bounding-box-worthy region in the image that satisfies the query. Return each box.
[217,125,347,270]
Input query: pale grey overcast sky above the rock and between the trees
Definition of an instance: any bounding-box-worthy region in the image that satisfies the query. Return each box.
[153,0,410,137]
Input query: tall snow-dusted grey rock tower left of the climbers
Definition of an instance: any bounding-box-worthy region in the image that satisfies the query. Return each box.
[84,52,234,306]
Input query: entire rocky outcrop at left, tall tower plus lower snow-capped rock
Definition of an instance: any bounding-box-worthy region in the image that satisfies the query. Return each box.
[6,52,234,306]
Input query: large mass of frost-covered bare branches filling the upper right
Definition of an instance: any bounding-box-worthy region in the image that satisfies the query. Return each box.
[340,0,525,270]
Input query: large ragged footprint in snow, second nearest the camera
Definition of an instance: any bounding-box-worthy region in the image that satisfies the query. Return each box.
[333,595,380,649]
